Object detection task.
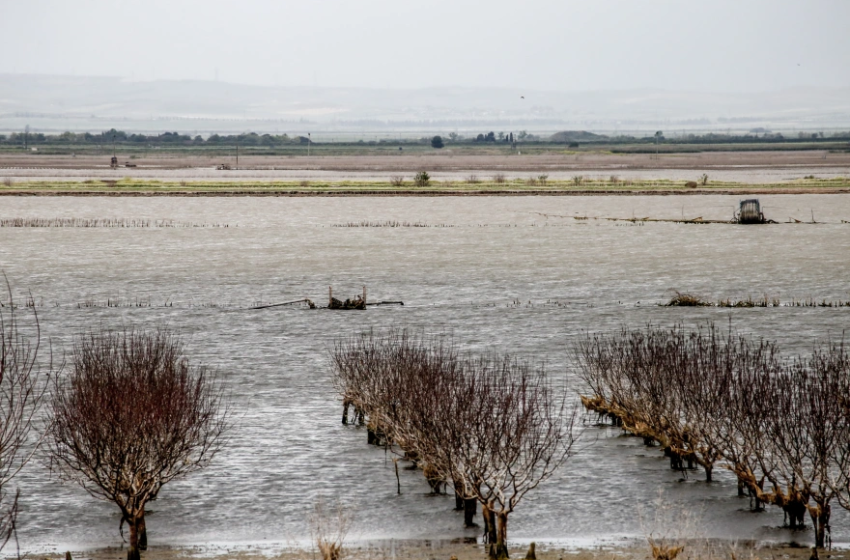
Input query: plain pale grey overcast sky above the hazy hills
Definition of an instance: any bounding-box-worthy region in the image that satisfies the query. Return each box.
[0,0,850,92]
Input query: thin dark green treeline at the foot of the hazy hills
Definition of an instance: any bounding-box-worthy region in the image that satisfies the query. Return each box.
[0,128,850,147]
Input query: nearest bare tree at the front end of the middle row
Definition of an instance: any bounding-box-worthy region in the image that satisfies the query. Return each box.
[444,355,575,559]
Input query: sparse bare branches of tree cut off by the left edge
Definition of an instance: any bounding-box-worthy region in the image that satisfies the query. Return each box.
[0,281,50,550]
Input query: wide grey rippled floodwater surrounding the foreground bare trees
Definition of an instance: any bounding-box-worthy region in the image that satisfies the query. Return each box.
[0,195,850,551]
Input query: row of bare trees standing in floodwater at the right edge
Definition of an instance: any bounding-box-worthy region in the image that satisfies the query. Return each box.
[576,325,850,547]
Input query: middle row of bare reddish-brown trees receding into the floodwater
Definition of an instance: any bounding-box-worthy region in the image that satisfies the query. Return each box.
[332,330,576,559]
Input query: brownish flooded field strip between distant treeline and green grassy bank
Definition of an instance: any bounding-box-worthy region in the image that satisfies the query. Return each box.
[0,148,850,184]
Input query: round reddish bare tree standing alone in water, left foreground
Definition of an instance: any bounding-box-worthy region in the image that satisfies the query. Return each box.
[51,329,229,560]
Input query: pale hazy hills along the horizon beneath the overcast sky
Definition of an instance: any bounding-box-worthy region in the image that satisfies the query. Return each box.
[0,74,850,136]
